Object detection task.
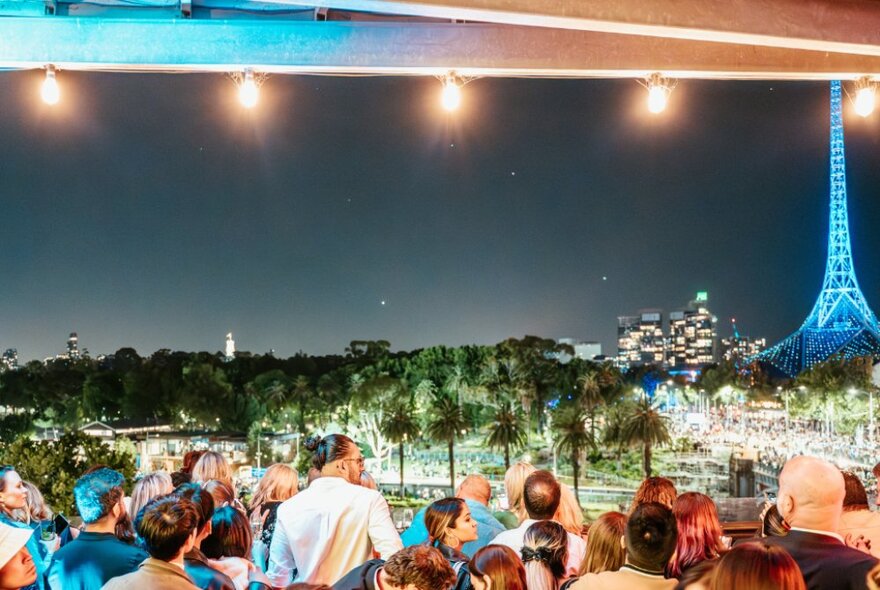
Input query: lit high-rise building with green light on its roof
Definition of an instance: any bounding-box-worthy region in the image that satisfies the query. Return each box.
[666,291,718,367]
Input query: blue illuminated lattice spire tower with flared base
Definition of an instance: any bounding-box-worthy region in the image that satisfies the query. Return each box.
[753,81,880,377]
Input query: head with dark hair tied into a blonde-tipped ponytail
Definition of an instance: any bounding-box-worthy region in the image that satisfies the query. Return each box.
[520,520,568,590]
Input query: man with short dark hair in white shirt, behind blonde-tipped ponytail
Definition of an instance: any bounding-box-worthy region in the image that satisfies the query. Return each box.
[490,471,587,577]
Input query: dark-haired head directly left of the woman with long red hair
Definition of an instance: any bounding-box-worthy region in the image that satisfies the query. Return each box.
[625,502,678,571]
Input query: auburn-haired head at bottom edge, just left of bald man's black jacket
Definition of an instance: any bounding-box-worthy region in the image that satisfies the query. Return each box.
[709,541,806,590]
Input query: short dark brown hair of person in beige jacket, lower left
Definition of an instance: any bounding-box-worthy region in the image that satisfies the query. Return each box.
[135,496,199,561]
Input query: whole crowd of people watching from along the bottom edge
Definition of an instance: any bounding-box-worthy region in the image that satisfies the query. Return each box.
[0,434,880,590]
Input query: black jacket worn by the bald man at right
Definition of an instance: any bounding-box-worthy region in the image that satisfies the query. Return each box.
[766,530,877,590]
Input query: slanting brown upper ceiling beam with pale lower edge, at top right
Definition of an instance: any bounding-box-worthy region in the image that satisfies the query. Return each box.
[266,0,880,55]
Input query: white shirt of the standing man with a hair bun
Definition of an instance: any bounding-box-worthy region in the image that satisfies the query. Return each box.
[266,476,403,588]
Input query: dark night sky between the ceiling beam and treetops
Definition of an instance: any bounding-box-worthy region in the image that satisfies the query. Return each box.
[0,72,880,360]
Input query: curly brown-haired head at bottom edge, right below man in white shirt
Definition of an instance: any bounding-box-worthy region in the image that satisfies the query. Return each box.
[380,545,456,590]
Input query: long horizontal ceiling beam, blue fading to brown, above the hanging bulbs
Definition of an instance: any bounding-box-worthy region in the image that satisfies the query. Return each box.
[0,17,880,80]
